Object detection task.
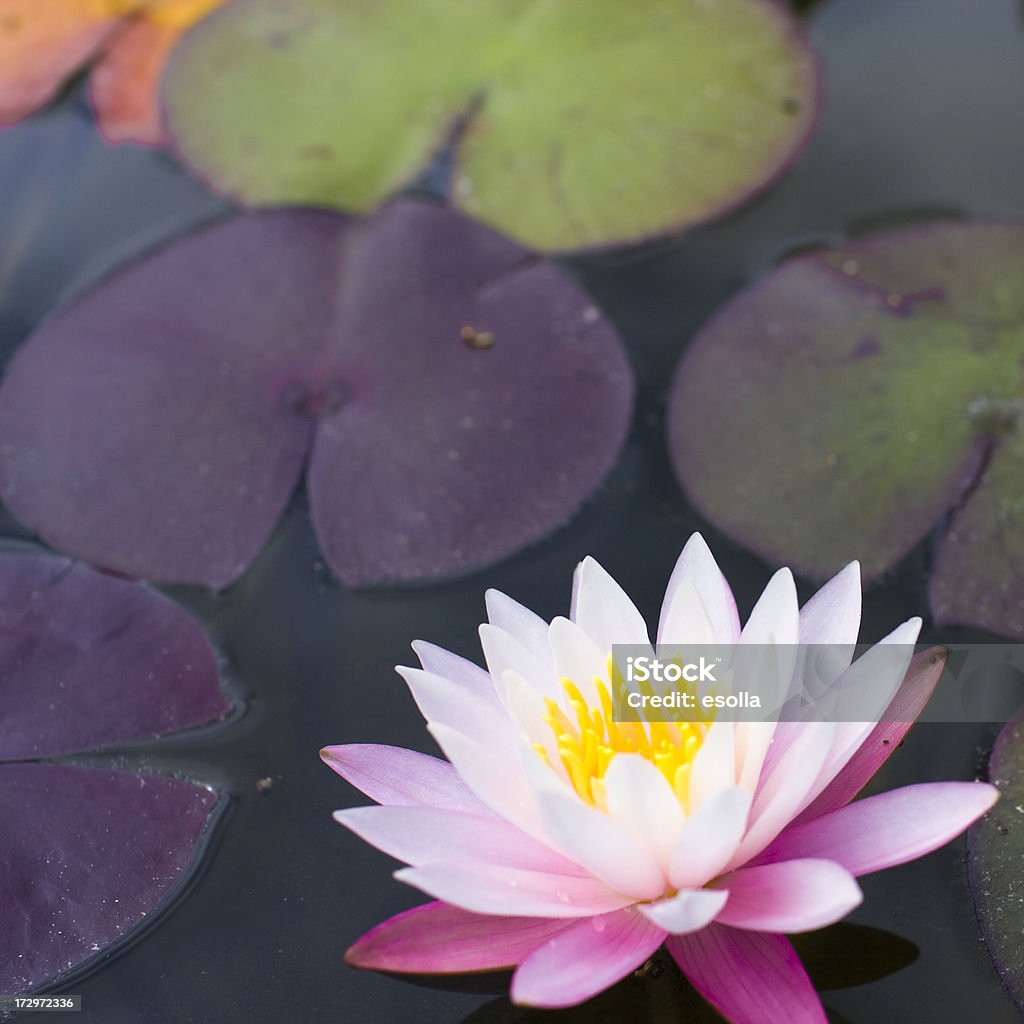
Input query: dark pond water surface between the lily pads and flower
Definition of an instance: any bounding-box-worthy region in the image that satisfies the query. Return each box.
[0,0,1024,1024]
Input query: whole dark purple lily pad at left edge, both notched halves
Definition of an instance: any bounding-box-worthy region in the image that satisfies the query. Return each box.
[0,553,230,994]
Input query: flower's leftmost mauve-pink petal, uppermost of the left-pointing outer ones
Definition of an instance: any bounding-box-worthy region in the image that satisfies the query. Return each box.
[321,743,492,815]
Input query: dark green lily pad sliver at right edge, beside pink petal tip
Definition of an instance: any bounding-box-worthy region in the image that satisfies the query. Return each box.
[968,711,1024,1013]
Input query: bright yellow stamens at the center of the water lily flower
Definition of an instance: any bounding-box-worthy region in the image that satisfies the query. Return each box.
[535,655,711,813]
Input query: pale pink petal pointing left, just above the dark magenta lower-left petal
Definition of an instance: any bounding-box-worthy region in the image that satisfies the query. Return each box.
[394,861,633,918]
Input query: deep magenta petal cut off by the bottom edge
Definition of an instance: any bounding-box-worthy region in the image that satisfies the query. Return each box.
[666,924,827,1024]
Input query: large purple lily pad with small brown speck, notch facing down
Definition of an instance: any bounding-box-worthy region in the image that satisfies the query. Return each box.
[0,202,633,588]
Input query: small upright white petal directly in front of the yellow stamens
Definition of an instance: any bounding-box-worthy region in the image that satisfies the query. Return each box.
[604,754,684,877]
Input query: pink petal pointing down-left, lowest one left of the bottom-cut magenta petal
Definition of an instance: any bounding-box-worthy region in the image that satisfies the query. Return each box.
[511,908,665,1008]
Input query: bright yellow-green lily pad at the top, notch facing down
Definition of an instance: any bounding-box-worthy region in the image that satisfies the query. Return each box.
[164,0,817,250]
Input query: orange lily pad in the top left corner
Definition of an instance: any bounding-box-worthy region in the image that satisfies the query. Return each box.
[0,0,224,145]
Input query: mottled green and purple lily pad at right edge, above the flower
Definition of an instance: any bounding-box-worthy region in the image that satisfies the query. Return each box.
[669,221,1024,636]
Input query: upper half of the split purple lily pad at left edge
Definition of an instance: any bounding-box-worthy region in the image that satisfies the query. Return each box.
[0,554,230,761]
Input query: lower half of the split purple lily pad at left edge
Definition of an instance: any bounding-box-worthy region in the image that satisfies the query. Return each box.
[0,764,217,994]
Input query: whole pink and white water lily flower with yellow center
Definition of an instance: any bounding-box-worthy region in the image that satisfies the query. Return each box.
[322,535,996,1024]
